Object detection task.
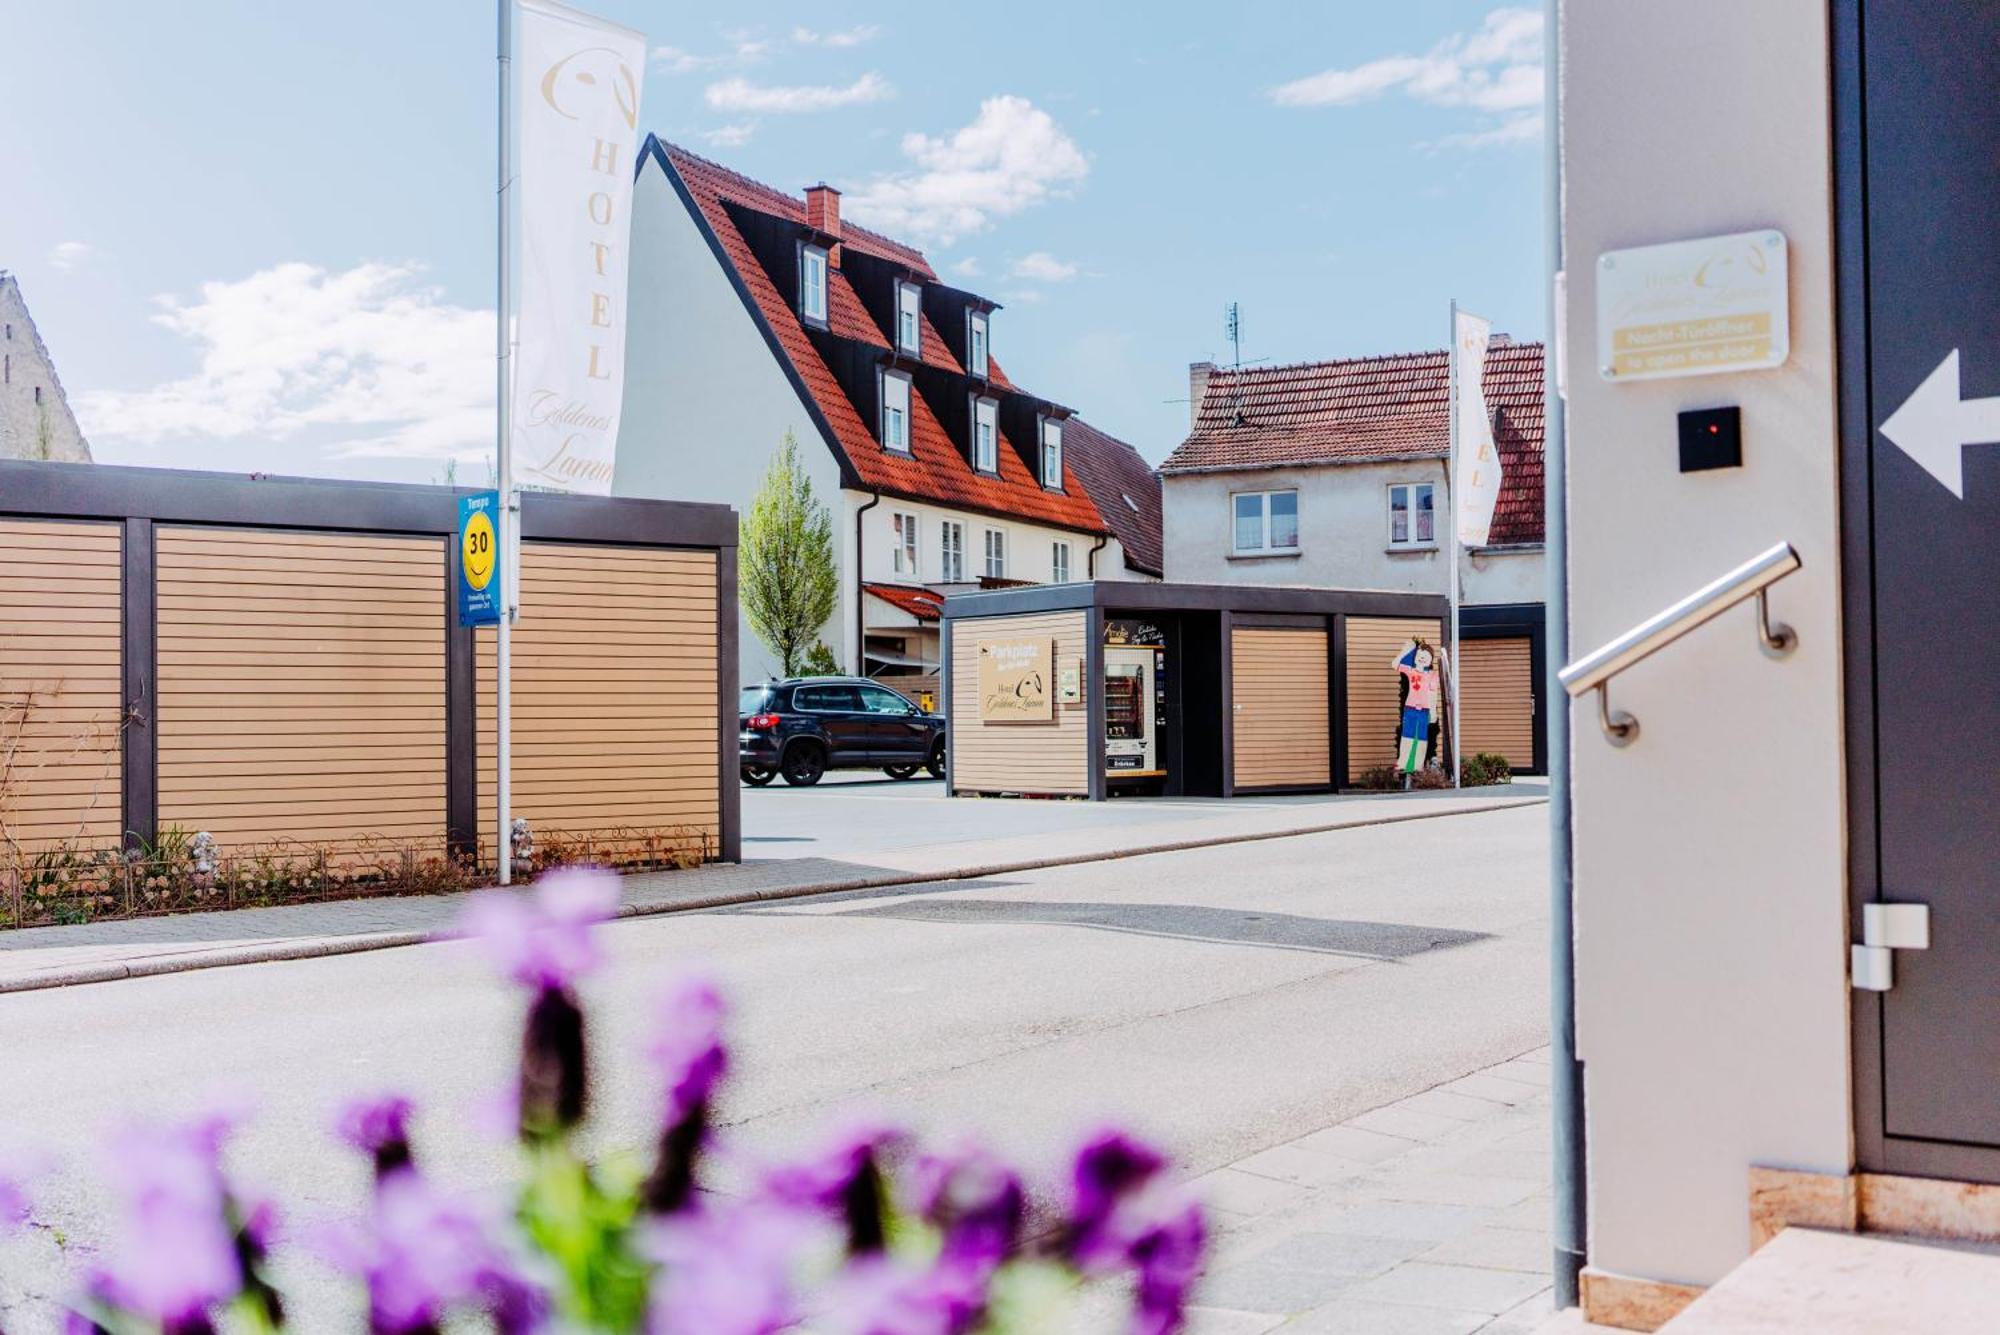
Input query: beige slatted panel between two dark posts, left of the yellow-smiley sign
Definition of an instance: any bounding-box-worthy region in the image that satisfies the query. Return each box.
[154,526,446,853]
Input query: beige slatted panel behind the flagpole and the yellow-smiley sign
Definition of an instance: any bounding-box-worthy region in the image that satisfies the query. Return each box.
[478,542,734,847]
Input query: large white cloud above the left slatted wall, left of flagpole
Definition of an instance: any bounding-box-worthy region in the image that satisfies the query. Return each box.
[76,262,494,460]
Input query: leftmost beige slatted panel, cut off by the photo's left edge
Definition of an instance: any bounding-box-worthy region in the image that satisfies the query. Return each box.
[0,520,122,861]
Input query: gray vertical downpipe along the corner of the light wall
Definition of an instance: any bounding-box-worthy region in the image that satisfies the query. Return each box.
[1542,0,1588,1307]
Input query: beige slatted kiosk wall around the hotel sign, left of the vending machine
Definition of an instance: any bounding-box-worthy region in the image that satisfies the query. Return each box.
[950,612,1100,795]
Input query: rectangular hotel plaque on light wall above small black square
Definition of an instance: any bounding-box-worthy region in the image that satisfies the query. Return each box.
[1598,230,1792,382]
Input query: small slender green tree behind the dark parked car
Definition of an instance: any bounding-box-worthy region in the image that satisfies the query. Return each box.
[738,432,840,677]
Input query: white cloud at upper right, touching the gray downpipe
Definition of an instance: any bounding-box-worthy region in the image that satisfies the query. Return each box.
[1270,8,1542,146]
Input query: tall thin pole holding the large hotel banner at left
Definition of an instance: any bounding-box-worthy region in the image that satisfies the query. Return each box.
[494,0,520,885]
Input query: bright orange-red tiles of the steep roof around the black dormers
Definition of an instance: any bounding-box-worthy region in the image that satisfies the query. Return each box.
[662,142,1104,534]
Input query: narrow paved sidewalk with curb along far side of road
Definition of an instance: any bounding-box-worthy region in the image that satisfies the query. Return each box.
[0,781,1546,993]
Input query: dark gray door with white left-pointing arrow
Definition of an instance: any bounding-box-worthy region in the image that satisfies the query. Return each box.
[1836,0,2000,1177]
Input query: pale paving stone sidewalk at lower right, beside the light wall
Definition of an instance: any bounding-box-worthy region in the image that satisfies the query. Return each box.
[1188,1047,1556,1335]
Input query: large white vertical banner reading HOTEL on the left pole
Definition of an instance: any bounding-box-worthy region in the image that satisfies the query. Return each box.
[512,0,646,496]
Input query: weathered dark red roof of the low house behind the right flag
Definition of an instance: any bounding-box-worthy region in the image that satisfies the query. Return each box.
[1160,349,1542,546]
